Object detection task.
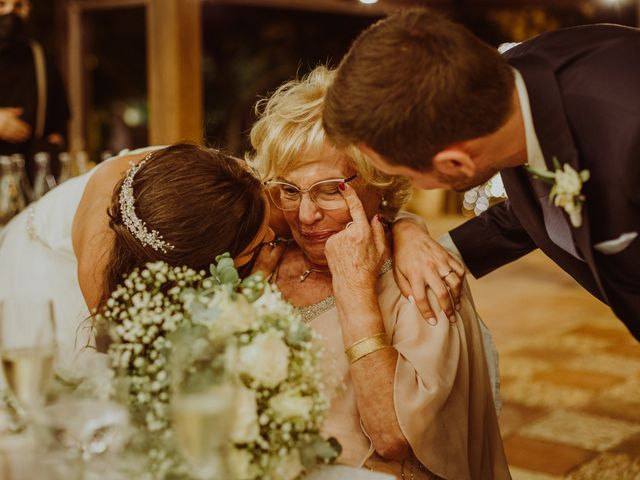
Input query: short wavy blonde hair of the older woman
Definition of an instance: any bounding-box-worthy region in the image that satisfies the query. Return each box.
[246,66,410,216]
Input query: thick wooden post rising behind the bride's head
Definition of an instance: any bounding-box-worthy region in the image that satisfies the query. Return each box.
[147,0,204,145]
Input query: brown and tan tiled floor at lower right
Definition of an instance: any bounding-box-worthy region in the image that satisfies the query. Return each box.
[422,218,640,480]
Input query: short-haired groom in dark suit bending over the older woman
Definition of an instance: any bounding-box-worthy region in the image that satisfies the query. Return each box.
[323,6,640,339]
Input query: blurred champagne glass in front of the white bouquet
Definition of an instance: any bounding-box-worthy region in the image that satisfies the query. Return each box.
[171,344,237,480]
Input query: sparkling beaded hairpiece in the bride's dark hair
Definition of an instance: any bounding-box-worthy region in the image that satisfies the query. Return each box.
[119,152,175,253]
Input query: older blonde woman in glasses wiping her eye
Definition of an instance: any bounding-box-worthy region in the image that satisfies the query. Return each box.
[249,67,510,480]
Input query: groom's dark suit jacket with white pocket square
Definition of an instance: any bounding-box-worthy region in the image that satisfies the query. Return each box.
[451,25,640,340]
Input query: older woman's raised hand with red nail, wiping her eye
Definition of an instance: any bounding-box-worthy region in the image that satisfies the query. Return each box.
[325,180,387,294]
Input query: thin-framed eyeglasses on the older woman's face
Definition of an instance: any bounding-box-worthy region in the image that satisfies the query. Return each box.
[265,174,358,211]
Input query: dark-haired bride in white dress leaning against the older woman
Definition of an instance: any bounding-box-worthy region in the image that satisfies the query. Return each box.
[0,144,274,366]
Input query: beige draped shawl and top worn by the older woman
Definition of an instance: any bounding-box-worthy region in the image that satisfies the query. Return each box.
[310,272,511,480]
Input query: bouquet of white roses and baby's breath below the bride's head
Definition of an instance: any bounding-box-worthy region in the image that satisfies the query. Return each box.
[100,254,340,480]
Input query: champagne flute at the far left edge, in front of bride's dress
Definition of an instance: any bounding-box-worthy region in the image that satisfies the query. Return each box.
[0,297,56,415]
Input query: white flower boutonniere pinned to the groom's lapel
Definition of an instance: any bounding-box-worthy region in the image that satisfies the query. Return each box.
[526,157,589,227]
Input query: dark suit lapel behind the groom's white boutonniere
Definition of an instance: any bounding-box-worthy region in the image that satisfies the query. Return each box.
[505,55,604,300]
